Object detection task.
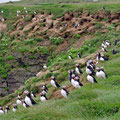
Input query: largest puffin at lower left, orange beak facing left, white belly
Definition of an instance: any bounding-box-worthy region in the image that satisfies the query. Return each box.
[23,90,36,107]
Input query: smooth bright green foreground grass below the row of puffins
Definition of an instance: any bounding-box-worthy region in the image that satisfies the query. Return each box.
[0,50,120,120]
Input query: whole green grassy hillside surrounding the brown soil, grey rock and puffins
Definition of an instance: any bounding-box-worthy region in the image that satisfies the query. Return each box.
[0,0,120,120]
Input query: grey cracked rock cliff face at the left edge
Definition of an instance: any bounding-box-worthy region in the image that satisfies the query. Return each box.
[0,52,48,96]
